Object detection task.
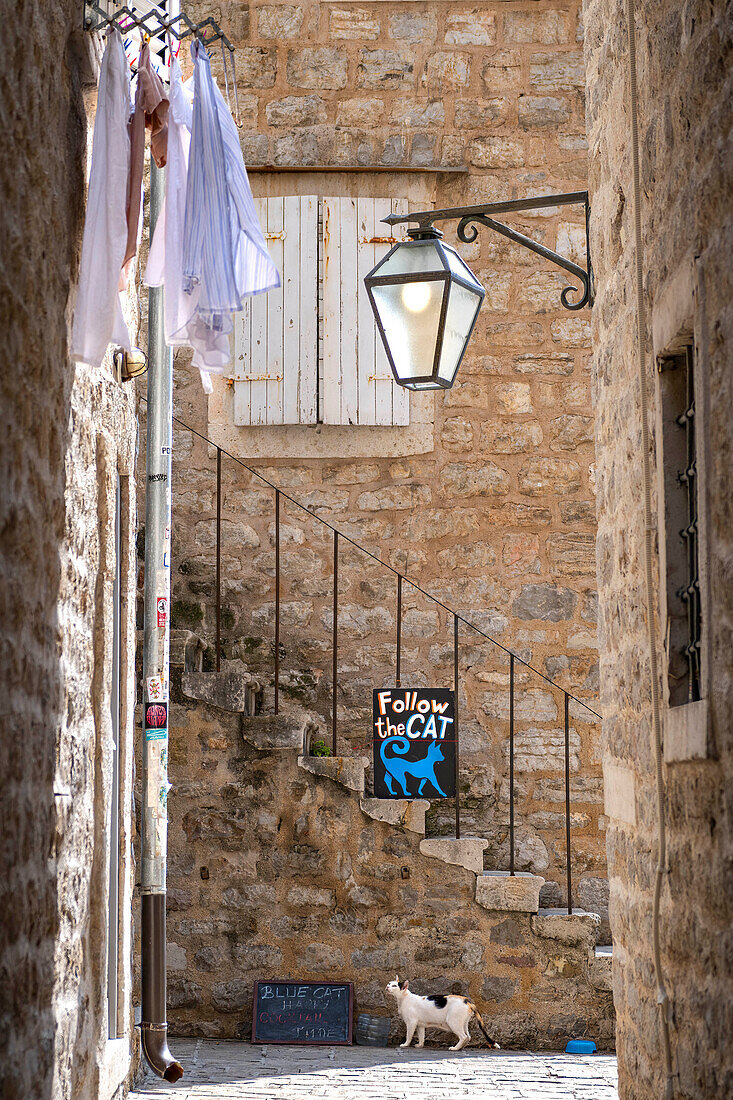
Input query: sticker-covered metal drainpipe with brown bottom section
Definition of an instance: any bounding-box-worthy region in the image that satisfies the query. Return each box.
[141,157,183,1081]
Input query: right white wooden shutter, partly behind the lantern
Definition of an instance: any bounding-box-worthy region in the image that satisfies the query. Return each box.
[321,198,409,425]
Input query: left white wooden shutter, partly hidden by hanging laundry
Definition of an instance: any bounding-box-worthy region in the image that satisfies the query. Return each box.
[234,195,318,426]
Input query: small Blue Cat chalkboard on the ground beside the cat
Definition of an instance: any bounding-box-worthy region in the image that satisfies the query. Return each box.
[252,981,353,1046]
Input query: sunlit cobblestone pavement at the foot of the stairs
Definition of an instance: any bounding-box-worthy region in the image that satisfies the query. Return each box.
[130,1040,619,1100]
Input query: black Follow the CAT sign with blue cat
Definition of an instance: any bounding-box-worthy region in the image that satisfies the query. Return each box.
[373,688,458,799]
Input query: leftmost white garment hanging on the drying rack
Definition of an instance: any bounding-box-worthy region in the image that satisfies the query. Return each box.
[72,30,132,366]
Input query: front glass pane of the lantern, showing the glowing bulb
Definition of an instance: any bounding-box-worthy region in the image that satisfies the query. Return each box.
[372,279,446,381]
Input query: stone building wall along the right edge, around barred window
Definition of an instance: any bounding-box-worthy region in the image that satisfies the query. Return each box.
[584,0,733,1098]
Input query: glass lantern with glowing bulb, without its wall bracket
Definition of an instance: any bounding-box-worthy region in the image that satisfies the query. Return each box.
[364,227,485,389]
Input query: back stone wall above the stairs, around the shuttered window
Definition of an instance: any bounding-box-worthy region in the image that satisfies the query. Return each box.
[154,2,605,912]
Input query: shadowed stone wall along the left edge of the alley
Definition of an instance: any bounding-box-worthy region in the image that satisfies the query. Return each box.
[0,15,136,1100]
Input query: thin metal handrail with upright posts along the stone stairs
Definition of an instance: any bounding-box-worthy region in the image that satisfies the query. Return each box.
[148,397,602,913]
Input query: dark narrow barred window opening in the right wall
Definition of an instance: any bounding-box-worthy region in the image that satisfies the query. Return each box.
[659,344,702,706]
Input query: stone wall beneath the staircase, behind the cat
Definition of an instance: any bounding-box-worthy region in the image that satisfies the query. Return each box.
[162,677,613,1049]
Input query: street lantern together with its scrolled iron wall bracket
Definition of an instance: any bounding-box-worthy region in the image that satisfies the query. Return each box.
[364,191,593,389]
